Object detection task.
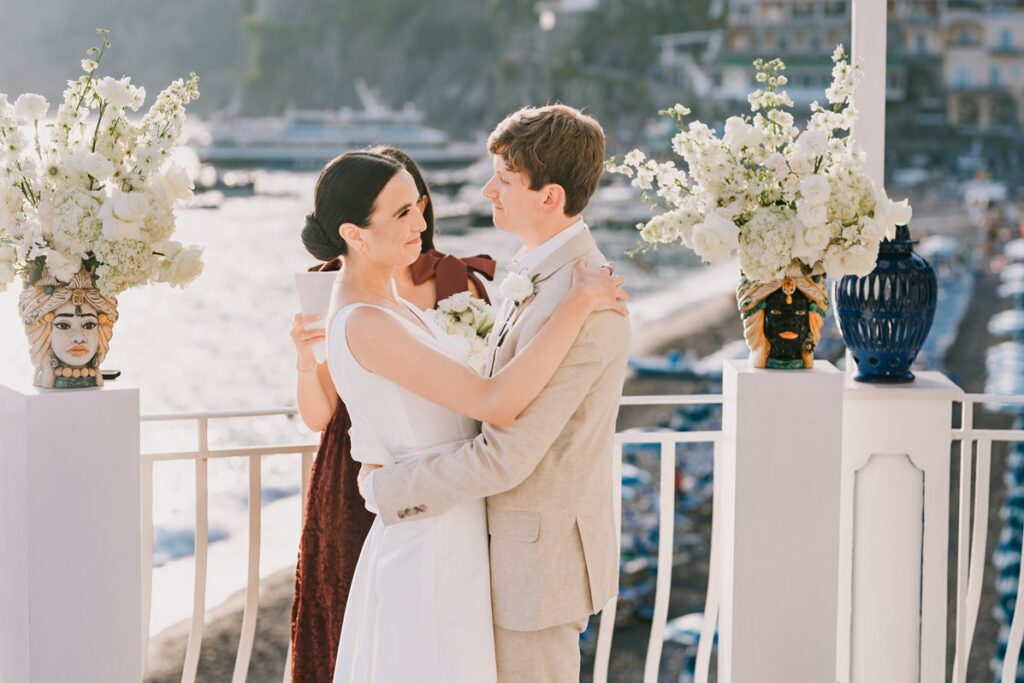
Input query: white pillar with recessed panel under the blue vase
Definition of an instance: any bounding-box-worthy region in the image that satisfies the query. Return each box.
[836,372,964,683]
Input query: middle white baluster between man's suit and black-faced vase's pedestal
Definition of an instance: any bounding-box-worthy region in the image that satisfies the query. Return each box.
[643,436,676,683]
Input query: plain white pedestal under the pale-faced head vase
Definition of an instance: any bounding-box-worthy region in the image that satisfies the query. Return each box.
[0,385,142,683]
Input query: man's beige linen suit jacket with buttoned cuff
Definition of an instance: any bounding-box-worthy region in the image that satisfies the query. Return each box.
[372,230,630,631]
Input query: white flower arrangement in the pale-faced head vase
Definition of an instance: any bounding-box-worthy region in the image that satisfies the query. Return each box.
[0,29,203,297]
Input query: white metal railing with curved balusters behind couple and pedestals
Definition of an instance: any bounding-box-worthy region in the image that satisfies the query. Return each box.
[141,394,1024,683]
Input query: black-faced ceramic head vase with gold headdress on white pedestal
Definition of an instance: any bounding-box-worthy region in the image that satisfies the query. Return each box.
[736,263,828,370]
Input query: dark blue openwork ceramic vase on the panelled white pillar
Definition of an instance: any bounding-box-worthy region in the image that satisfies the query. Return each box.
[833,225,938,383]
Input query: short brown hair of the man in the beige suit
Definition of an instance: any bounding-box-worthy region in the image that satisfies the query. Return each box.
[487,104,604,216]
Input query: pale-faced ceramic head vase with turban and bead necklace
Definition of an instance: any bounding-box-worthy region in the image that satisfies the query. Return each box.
[18,270,118,389]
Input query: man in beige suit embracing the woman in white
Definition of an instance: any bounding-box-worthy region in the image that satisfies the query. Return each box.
[362,104,630,683]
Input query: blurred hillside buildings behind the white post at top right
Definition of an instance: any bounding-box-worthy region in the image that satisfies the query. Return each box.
[655,0,1024,134]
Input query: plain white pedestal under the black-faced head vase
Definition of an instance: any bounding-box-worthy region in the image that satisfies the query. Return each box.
[719,360,844,683]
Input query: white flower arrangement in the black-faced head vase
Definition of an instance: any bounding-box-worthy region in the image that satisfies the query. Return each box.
[608,45,912,283]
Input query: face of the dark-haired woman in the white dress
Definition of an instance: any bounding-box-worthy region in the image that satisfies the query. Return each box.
[355,170,427,266]
